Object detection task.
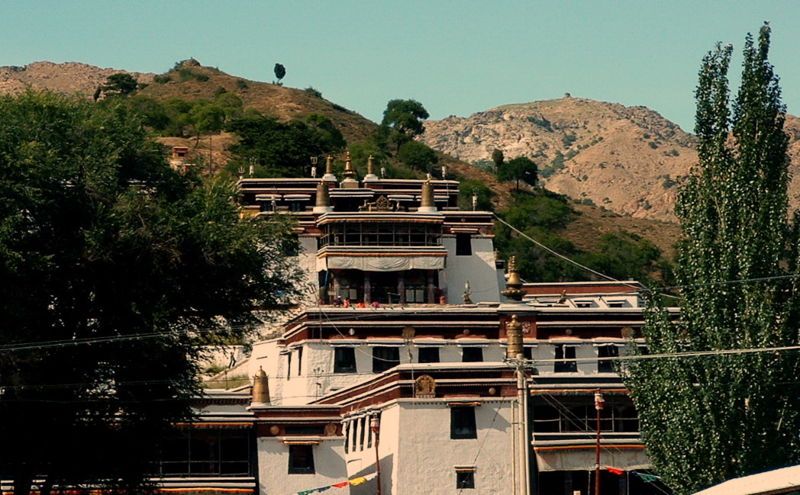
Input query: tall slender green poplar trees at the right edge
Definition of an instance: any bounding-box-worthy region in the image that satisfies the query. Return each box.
[623,25,800,494]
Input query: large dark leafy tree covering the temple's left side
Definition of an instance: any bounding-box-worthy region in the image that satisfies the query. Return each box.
[0,93,297,494]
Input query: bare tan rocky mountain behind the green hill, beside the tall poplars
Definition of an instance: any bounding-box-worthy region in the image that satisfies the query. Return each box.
[422,96,800,222]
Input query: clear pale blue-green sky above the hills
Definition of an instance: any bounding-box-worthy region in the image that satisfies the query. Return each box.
[0,0,800,130]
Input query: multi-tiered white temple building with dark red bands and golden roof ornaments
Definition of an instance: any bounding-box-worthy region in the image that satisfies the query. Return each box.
[155,156,677,495]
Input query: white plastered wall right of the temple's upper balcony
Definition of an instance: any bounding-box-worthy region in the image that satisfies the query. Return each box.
[439,235,500,304]
